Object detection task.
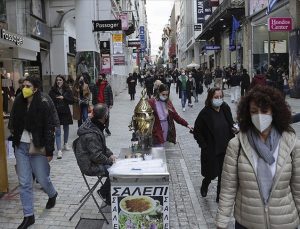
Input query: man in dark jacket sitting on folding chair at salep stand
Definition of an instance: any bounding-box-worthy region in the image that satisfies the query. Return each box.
[73,104,116,205]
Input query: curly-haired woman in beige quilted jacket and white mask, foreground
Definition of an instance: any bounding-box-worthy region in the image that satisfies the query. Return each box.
[216,86,300,229]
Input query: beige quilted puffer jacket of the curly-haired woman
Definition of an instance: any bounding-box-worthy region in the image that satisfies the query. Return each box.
[216,132,300,229]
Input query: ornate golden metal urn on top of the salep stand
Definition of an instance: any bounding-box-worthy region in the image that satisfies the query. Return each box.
[129,89,155,148]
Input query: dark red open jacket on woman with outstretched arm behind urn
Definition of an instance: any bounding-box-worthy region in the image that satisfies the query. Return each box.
[148,98,188,144]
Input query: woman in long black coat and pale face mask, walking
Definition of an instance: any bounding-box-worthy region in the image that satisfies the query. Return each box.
[194,87,234,202]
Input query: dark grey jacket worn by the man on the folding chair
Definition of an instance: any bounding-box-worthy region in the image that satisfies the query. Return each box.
[73,119,113,176]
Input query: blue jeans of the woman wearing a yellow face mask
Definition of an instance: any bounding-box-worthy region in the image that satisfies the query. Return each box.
[15,142,56,217]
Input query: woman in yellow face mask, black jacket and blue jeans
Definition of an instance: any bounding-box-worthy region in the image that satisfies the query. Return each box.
[8,76,58,229]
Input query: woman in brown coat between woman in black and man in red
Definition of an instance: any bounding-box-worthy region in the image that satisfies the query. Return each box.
[73,76,90,127]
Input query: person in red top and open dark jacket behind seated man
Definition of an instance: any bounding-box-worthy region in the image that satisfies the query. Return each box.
[92,74,114,136]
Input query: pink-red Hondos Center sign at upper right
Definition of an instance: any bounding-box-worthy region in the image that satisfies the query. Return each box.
[268,17,293,32]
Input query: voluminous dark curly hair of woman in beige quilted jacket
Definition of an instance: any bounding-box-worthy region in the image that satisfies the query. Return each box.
[237,85,294,133]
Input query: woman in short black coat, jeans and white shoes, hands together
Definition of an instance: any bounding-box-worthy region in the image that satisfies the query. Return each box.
[49,75,73,159]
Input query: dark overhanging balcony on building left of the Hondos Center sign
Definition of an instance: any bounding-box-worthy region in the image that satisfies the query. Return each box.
[197,0,245,40]
